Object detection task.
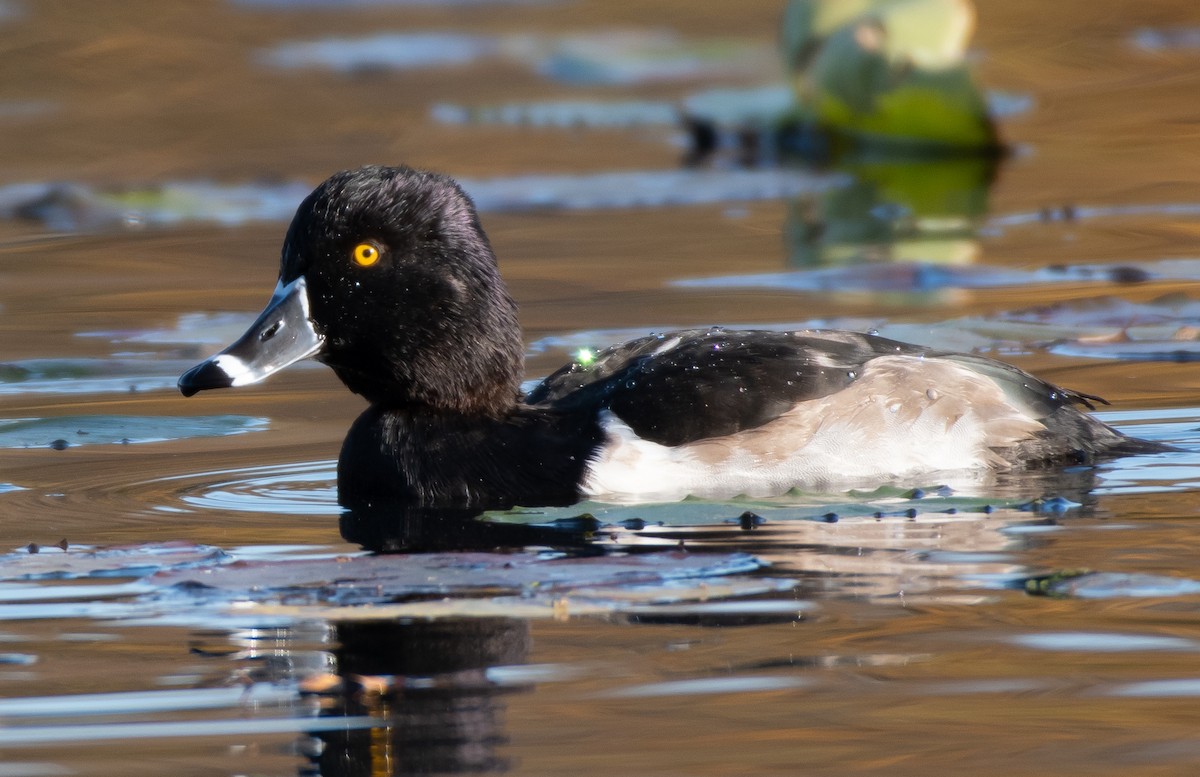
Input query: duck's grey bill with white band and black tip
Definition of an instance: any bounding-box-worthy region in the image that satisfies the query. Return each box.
[179,276,324,397]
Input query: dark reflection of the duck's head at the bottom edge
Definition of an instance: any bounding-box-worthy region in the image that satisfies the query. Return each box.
[301,619,532,777]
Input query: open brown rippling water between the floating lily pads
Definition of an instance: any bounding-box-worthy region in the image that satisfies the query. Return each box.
[0,0,1200,776]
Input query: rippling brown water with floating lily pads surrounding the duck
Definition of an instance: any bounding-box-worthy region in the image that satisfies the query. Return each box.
[0,0,1200,777]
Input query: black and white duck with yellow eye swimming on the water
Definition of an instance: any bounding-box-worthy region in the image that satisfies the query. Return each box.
[179,165,1164,508]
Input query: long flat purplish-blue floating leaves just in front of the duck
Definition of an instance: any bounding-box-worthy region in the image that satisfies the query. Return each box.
[0,543,804,624]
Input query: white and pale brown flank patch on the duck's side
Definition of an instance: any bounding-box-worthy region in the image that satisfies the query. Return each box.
[583,356,1044,501]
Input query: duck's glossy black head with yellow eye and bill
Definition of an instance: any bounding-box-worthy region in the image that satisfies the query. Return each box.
[180,167,522,416]
